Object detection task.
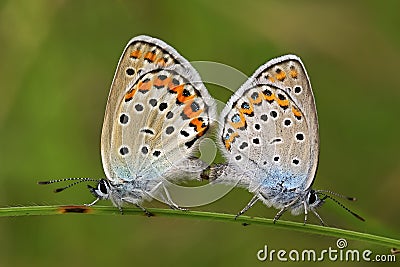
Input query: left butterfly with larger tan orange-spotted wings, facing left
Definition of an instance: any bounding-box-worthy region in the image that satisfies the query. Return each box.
[39,36,216,216]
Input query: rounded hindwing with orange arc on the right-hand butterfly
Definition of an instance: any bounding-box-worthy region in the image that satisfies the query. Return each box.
[221,84,311,191]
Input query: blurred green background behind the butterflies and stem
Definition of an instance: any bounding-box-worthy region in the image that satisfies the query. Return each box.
[0,0,400,266]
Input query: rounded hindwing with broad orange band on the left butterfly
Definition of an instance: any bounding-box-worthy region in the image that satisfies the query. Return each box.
[109,66,214,180]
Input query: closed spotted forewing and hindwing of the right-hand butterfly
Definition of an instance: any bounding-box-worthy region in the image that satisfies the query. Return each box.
[219,55,319,191]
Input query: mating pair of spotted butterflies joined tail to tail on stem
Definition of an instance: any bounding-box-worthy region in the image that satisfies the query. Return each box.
[39,36,361,224]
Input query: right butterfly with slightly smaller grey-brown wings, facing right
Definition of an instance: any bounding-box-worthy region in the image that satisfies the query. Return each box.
[209,55,364,225]
